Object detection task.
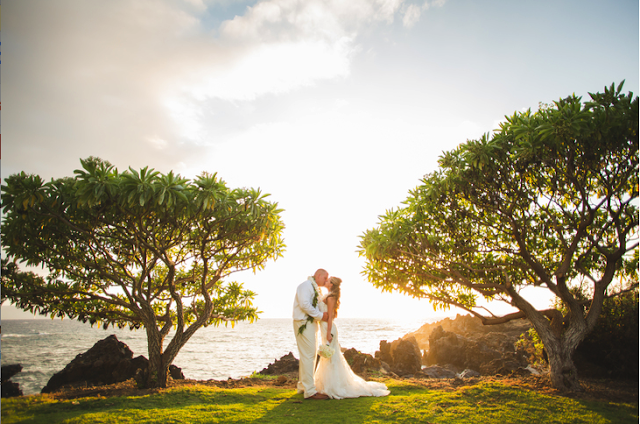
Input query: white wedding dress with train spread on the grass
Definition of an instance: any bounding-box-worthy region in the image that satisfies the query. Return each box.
[314,299,390,399]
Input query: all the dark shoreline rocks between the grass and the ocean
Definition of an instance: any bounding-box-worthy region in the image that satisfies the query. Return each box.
[2,315,624,397]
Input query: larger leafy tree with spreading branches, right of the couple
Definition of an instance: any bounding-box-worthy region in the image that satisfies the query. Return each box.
[359,84,638,390]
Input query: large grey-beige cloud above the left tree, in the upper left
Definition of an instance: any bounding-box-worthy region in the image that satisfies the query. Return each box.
[2,0,210,178]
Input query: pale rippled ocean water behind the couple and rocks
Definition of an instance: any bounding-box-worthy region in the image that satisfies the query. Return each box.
[0,318,435,395]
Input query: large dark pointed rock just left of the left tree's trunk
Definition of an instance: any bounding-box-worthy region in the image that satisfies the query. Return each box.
[42,335,149,393]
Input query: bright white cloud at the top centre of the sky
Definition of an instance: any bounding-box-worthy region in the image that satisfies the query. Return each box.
[205,0,410,100]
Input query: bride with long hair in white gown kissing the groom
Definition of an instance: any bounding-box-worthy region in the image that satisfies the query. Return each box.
[314,277,389,399]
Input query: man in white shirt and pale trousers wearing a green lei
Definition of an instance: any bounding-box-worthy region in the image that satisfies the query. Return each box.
[293,269,329,399]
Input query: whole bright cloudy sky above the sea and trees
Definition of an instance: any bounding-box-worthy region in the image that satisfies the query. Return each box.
[1,0,639,320]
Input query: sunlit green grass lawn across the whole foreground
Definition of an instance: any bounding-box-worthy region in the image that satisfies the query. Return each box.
[2,380,638,424]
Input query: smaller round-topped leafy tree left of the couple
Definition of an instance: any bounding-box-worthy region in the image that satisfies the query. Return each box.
[2,158,284,387]
